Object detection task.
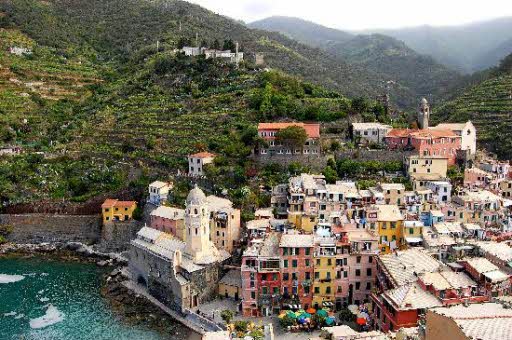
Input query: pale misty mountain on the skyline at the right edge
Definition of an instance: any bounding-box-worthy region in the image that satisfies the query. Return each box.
[368,17,512,73]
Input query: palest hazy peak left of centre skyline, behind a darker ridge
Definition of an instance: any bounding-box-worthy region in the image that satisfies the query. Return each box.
[248,16,354,47]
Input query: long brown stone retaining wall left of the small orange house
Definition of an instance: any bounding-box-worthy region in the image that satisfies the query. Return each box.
[0,214,101,244]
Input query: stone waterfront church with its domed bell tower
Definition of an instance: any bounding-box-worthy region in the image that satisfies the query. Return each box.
[129,186,230,312]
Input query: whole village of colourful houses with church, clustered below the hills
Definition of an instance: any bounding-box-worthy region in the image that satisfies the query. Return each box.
[62,99,512,340]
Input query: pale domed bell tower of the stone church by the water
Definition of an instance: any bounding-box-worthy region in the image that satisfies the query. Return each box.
[184,185,218,263]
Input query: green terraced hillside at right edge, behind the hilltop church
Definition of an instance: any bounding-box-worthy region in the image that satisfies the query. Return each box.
[434,54,512,159]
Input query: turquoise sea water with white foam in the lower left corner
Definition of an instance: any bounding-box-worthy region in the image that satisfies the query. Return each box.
[0,258,164,340]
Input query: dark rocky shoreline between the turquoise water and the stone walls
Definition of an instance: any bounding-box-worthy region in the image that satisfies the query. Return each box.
[0,242,191,339]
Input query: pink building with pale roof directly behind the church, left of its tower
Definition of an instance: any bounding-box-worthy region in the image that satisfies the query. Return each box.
[150,206,185,241]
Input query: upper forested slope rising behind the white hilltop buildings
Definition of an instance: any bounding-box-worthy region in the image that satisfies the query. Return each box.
[2,0,383,97]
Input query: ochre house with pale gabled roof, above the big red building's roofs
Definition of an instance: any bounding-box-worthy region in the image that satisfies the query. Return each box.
[376,205,404,254]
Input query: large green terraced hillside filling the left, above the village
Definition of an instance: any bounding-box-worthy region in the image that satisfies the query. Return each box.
[0,0,388,205]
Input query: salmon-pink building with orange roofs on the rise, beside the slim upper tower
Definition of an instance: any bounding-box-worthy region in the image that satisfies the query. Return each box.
[386,129,461,165]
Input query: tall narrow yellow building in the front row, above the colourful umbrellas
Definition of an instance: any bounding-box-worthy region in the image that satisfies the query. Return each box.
[313,238,336,309]
